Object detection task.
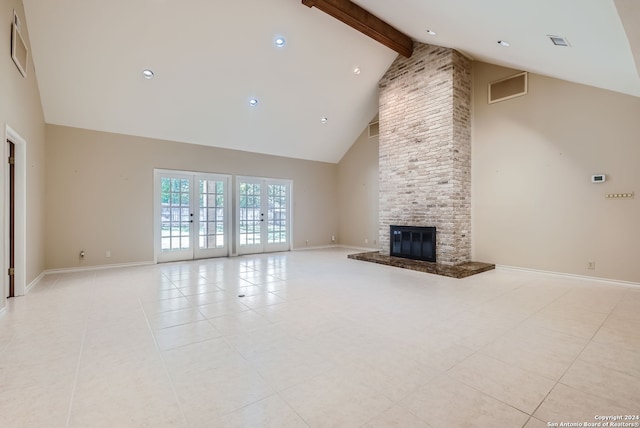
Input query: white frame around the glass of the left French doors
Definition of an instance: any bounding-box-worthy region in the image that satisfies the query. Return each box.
[153,168,233,264]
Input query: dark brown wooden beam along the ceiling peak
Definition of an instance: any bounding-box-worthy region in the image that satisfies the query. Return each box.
[302,0,413,58]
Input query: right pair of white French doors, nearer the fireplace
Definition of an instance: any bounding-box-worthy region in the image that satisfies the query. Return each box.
[236,177,291,254]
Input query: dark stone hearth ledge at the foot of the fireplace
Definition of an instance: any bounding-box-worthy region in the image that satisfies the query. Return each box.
[347,251,496,279]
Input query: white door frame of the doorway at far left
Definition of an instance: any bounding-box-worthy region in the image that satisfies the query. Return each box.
[1,125,27,297]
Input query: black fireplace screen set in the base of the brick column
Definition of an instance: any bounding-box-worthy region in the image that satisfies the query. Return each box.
[391,226,436,262]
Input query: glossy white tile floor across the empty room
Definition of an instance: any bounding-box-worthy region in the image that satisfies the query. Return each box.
[0,249,640,428]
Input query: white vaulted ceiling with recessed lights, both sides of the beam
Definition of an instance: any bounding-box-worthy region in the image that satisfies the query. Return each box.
[23,0,640,162]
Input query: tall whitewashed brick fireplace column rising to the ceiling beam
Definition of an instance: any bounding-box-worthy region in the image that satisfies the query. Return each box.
[379,43,471,265]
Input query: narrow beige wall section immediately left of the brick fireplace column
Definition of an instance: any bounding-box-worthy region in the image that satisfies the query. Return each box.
[336,128,379,249]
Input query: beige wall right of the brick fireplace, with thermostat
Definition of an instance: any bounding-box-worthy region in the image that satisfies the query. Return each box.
[472,63,640,282]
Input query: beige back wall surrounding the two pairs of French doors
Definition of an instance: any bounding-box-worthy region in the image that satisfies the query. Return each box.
[46,125,338,269]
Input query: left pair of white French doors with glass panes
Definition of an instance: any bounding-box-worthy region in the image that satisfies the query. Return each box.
[154,170,231,263]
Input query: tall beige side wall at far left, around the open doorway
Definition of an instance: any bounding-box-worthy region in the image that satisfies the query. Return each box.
[0,0,45,308]
